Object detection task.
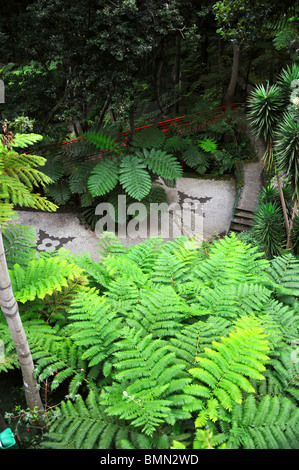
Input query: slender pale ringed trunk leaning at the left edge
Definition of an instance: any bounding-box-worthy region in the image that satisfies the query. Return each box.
[0,227,45,426]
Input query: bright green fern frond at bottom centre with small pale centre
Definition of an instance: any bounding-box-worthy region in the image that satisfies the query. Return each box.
[101,329,190,435]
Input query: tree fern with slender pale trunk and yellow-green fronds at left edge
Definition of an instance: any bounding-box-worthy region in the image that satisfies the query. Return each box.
[0,124,57,425]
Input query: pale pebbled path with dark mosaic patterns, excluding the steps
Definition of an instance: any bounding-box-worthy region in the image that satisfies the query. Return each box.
[14,177,236,260]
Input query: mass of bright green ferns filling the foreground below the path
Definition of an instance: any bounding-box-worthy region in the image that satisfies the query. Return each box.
[0,231,299,449]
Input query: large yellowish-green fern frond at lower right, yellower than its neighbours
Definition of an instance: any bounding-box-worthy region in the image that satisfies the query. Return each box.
[185,317,269,427]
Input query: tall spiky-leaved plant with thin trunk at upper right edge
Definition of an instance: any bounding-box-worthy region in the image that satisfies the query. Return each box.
[248,65,299,252]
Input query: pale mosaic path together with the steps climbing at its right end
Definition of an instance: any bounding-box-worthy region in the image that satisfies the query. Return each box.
[15,105,265,260]
